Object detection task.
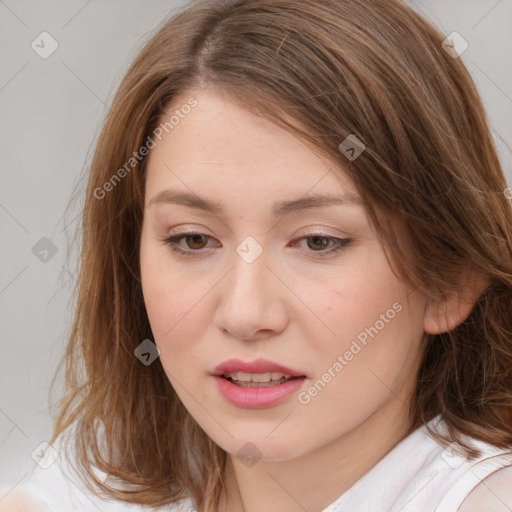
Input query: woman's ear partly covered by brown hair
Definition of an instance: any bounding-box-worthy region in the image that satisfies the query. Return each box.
[423,271,490,334]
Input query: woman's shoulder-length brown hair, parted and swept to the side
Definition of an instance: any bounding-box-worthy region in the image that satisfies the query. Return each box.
[52,0,512,512]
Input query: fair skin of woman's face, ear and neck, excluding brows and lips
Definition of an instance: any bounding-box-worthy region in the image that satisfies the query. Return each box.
[140,90,476,512]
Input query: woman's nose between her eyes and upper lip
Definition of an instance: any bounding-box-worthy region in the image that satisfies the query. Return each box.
[214,246,289,341]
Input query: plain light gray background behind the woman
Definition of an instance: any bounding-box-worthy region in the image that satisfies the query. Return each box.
[0,0,512,492]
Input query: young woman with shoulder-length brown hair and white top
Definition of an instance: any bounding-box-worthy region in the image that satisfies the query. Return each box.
[5,0,512,512]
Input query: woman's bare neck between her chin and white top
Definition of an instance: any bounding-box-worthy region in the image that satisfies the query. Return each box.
[218,397,411,512]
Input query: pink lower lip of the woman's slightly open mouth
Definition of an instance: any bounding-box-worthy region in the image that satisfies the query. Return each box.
[214,376,306,409]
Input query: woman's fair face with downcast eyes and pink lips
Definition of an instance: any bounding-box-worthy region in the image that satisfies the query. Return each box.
[140,91,426,460]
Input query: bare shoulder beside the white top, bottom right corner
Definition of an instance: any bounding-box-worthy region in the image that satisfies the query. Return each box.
[459,466,512,512]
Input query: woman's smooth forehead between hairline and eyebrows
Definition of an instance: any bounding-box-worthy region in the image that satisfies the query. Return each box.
[146,91,357,202]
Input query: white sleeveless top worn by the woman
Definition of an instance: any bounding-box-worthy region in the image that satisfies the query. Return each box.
[8,416,512,512]
